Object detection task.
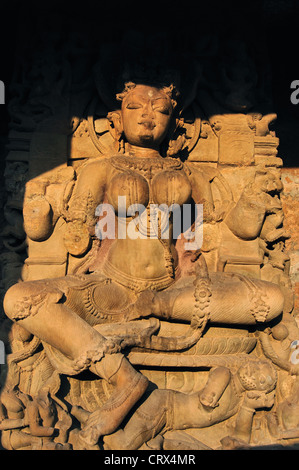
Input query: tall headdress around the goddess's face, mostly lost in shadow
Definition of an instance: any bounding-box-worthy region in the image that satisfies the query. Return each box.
[93,31,200,156]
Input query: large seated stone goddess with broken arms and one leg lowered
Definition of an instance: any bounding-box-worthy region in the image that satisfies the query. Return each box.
[4,84,284,444]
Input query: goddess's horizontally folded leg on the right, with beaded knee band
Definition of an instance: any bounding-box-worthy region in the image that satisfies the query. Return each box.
[153,273,284,325]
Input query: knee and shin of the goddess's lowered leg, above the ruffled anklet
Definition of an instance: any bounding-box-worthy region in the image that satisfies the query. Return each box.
[4,281,111,360]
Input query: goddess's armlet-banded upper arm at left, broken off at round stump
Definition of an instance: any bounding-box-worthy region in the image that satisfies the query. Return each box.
[64,160,107,256]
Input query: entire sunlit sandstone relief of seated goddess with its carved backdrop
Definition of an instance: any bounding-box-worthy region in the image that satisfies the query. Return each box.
[0,26,299,450]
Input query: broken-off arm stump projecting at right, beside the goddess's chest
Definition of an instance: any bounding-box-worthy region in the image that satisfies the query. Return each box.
[225,171,281,240]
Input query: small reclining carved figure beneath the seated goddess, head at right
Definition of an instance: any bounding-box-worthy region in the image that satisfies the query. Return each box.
[101,360,277,450]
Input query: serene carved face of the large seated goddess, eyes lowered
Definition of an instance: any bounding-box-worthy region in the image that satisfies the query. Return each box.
[121,85,173,149]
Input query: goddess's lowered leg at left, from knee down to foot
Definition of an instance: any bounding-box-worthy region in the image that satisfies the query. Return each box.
[4,280,148,440]
